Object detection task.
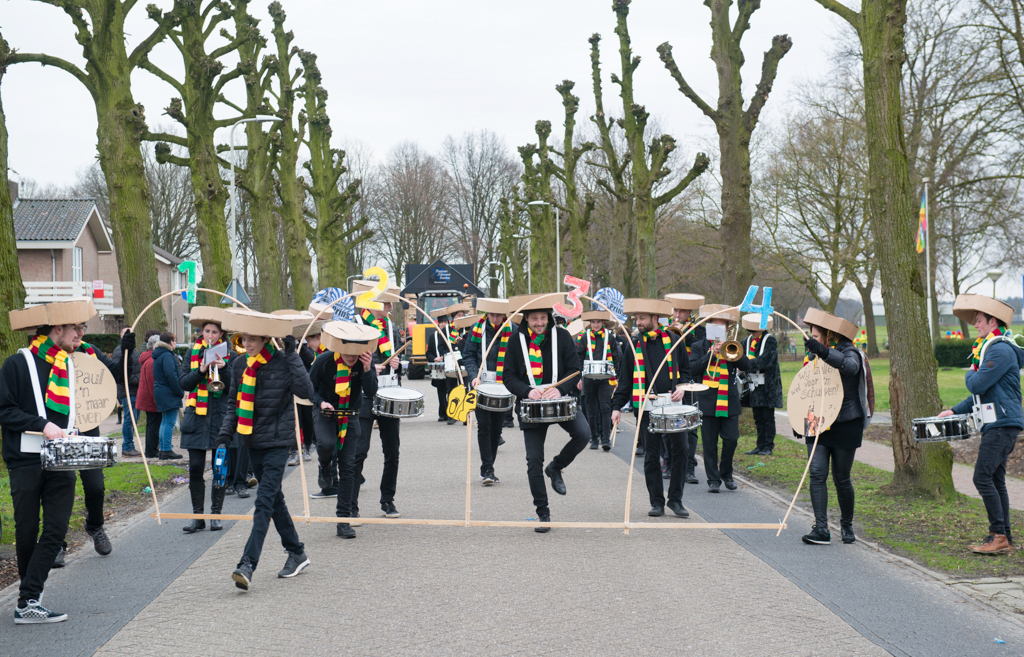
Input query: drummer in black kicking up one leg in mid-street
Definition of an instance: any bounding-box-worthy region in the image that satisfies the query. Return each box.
[503,295,590,533]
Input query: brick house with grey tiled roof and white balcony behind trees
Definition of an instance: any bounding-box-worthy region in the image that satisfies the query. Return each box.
[11,183,188,339]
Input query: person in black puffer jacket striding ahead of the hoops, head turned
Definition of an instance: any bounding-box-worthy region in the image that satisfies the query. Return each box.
[217,308,312,590]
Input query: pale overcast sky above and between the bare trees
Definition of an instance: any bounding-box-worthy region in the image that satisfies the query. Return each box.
[0,0,842,185]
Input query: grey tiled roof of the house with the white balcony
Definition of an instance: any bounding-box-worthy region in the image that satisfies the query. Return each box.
[14,199,114,253]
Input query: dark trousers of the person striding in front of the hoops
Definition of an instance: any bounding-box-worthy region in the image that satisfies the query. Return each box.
[240,447,303,570]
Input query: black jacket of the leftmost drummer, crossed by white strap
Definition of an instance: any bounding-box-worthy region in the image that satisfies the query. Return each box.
[0,353,68,468]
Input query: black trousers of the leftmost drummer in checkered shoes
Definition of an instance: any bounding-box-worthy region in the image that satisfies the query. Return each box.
[8,464,75,601]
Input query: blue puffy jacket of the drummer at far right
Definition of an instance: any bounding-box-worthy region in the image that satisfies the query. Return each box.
[953,340,1024,433]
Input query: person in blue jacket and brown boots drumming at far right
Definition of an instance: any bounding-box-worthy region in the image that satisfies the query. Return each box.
[939,295,1024,555]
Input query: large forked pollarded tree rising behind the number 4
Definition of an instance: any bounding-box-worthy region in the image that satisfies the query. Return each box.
[657,0,793,303]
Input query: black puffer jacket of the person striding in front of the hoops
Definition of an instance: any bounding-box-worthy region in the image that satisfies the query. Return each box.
[217,350,312,449]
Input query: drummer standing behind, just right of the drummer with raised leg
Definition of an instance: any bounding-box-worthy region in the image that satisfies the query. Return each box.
[577,310,620,451]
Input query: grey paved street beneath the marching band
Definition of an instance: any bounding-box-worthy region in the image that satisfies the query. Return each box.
[6,382,1024,657]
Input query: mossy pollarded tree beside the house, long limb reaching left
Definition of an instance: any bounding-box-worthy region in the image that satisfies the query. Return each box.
[8,0,177,332]
